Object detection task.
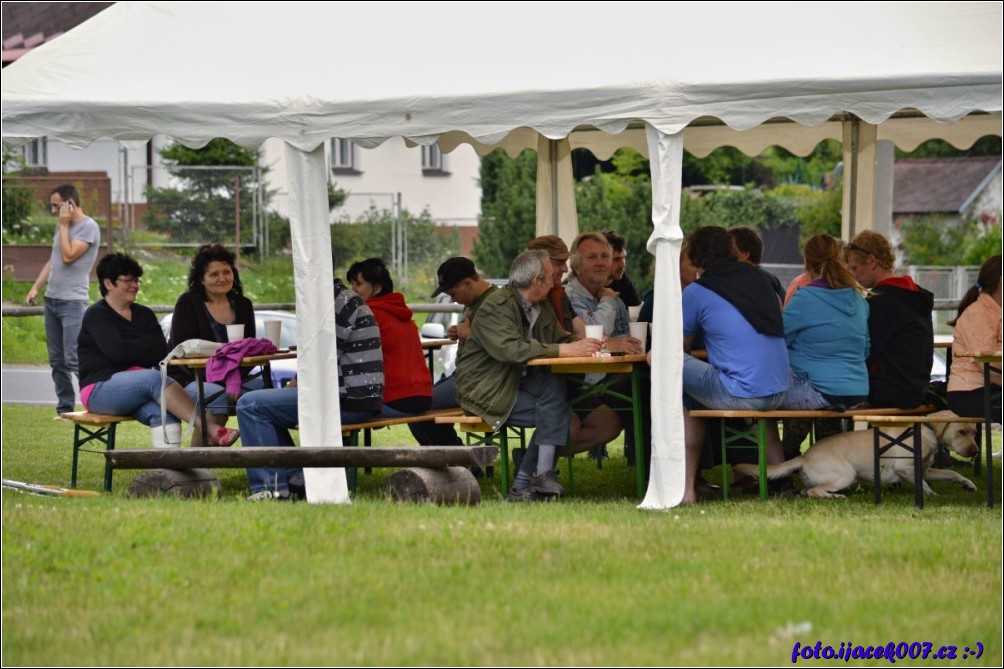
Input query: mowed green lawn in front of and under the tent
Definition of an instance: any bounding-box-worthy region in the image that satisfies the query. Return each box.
[2,405,1002,666]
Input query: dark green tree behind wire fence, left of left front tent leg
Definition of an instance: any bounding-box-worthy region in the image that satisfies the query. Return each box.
[144,139,272,243]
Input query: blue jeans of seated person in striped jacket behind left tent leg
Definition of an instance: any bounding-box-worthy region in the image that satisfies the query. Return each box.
[237,387,372,494]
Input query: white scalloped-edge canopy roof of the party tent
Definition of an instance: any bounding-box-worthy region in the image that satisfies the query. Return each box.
[2,2,1002,150]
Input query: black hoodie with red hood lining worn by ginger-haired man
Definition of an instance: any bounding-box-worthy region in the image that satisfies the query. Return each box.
[867,276,935,409]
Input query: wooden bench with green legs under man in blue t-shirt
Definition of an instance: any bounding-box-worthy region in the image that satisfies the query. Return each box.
[690,405,935,500]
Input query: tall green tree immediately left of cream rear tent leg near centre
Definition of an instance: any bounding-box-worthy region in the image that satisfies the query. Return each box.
[474,149,537,276]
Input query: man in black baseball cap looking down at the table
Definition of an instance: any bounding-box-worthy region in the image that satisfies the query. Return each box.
[409,257,498,448]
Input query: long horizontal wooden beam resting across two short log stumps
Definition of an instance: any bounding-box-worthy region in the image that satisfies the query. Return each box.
[104,446,499,469]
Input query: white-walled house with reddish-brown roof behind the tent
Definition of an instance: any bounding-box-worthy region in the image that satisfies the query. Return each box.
[2,2,481,252]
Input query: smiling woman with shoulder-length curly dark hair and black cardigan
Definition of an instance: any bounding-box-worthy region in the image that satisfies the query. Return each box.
[168,244,262,434]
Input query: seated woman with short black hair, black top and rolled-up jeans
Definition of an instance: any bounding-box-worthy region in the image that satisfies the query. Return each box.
[77,253,238,447]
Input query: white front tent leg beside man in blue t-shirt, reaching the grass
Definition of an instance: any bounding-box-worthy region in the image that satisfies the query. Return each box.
[636,127,686,509]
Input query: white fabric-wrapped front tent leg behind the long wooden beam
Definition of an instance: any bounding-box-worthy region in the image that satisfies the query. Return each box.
[286,145,349,503]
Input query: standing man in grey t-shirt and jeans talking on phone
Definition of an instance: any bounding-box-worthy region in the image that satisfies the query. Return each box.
[24,185,101,414]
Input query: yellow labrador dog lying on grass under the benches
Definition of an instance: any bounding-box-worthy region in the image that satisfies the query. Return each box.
[734,411,978,497]
